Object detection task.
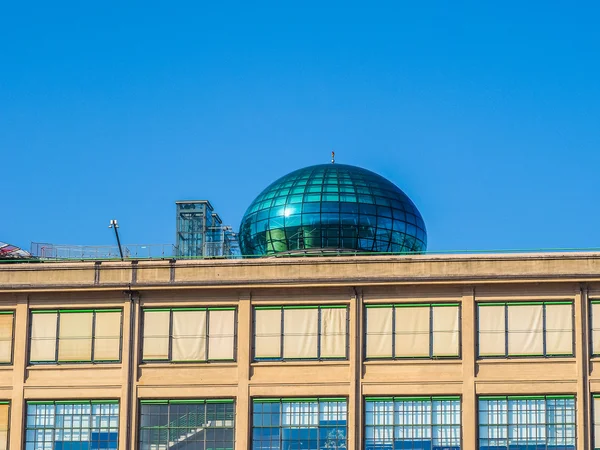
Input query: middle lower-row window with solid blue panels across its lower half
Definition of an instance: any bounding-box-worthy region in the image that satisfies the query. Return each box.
[252,398,348,450]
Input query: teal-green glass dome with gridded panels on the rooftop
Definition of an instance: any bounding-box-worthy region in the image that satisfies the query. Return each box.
[239,164,427,257]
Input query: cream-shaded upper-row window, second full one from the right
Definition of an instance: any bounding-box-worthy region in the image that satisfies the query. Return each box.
[365,303,460,359]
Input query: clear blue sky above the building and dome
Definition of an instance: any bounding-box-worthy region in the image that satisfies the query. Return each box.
[0,1,600,250]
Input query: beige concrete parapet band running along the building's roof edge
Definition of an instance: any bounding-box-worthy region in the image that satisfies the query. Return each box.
[0,252,600,292]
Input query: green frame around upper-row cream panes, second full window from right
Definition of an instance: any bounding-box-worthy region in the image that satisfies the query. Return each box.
[362,302,462,361]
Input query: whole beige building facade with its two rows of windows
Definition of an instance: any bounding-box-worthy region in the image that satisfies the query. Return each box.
[0,253,600,450]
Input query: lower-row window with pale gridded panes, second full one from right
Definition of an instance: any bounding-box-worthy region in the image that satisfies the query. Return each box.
[365,396,461,450]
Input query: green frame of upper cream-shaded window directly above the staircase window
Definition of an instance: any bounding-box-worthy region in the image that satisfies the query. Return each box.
[139,306,238,364]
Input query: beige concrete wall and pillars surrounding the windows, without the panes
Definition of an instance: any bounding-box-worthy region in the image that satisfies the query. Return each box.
[0,254,600,450]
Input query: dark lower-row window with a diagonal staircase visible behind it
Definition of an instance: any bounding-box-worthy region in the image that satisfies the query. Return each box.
[139,399,235,450]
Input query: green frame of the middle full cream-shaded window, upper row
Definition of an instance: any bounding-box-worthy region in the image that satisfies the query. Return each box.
[252,304,350,363]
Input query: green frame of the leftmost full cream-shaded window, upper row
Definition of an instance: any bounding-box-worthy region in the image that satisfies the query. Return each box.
[27,308,124,366]
